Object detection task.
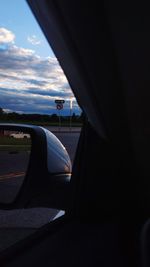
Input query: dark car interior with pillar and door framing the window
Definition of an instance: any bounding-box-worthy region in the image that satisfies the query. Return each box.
[0,0,150,267]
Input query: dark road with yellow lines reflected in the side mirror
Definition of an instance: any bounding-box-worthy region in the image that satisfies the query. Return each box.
[0,151,30,203]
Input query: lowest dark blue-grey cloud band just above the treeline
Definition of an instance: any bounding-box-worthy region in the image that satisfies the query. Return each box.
[0,88,80,115]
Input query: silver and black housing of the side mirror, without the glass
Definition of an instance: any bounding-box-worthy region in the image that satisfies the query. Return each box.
[0,123,72,210]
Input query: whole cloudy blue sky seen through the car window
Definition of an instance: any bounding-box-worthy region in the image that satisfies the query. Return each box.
[0,0,81,115]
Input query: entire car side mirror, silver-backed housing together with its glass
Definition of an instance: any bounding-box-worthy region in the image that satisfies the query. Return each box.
[0,124,72,209]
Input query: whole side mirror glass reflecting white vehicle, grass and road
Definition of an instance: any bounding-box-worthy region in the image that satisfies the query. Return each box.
[0,130,31,203]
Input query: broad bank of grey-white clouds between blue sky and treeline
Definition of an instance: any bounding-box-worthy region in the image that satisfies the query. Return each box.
[0,30,80,114]
